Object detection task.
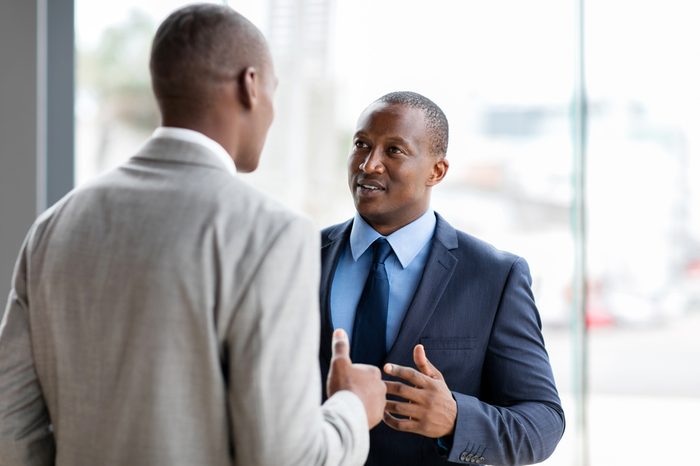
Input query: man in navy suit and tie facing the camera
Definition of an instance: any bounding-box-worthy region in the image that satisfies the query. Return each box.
[320,92,564,466]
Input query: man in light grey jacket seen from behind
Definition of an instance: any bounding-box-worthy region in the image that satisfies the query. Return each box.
[0,4,385,466]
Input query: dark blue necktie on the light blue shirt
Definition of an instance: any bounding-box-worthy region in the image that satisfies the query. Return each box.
[350,238,391,367]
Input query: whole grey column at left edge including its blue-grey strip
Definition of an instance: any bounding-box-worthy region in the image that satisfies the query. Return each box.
[0,0,74,317]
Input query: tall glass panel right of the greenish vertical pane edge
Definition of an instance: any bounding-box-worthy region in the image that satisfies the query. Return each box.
[586,0,700,465]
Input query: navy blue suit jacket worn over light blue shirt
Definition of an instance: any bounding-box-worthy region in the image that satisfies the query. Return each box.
[320,214,564,466]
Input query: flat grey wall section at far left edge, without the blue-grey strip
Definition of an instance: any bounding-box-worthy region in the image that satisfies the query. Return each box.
[0,0,42,314]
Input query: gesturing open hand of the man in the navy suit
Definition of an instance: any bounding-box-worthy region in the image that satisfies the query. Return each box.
[384,345,457,438]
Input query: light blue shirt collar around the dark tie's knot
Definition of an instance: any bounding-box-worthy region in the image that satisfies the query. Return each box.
[350,209,436,269]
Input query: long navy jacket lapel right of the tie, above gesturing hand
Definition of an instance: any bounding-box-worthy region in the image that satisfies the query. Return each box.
[387,214,457,364]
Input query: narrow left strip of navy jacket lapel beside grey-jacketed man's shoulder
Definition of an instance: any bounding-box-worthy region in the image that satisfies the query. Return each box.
[320,220,352,367]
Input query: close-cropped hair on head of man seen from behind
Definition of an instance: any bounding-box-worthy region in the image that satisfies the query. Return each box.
[150,4,271,113]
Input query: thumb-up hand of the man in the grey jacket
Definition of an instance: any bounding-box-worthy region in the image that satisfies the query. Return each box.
[326,329,386,429]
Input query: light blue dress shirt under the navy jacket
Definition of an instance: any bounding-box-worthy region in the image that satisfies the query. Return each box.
[331,209,436,352]
